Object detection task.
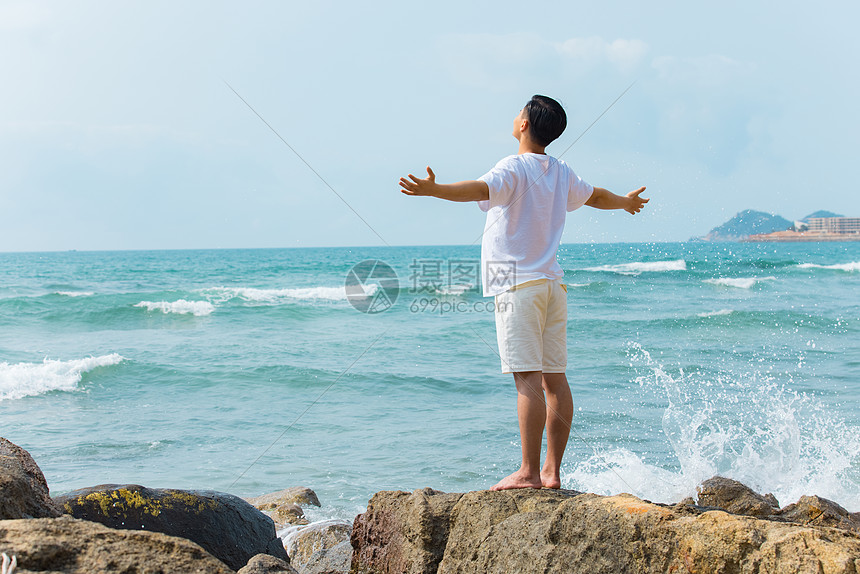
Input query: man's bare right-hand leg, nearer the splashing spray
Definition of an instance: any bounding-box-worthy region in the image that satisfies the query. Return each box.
[540,373,573,488]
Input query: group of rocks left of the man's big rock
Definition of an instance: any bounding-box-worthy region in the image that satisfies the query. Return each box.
[0,438,352,574]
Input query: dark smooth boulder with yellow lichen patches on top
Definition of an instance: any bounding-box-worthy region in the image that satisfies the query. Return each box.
[55,484,289,570]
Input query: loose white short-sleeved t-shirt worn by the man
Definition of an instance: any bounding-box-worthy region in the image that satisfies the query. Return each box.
[478,153,594,297]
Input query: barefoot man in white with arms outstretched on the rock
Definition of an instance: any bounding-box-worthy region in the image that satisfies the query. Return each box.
[400,96,648,490]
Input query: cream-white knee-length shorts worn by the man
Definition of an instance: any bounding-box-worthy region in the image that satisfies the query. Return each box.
[495,279,567,373]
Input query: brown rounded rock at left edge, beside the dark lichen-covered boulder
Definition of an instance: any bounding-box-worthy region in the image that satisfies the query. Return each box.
[0,438,63,520]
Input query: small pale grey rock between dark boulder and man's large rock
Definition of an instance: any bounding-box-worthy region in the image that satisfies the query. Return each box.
[284,520,352,574]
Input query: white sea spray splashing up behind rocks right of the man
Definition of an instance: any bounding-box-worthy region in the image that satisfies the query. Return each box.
[576,344,860,511]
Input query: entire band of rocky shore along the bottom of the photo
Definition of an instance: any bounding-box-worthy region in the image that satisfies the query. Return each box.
[0,438,860,574]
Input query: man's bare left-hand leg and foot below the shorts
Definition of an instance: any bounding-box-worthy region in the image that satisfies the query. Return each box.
[490,371,547,490]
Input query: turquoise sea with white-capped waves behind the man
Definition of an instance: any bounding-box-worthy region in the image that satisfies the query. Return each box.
[0,242,860,520]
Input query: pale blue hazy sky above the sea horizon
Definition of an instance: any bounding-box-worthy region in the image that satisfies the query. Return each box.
[0,0,860,251]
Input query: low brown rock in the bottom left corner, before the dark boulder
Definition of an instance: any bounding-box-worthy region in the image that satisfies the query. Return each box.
[0,516,233,574]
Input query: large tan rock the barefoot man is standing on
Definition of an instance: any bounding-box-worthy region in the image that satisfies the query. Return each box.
[351,489,860,574]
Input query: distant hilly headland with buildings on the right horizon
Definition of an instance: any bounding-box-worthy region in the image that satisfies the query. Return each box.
[692,209,860,242]
